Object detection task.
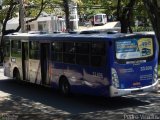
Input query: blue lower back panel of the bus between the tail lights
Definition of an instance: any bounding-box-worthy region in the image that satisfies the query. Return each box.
[113,62,157,89]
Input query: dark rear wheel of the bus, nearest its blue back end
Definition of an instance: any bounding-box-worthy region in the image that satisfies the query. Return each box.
[59,77,70,97]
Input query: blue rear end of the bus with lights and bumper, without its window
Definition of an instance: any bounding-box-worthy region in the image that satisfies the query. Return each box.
[110,36,159,97]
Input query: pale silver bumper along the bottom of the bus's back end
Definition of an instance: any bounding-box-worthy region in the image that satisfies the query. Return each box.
[110,80,159,97]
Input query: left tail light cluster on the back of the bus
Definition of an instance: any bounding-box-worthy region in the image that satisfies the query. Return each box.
[112,68,119,88]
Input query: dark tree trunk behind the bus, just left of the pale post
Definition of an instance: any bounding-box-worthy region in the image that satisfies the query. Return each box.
[63,0,70,32]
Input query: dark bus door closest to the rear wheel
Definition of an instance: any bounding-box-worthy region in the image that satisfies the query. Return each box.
[40,43,50,85]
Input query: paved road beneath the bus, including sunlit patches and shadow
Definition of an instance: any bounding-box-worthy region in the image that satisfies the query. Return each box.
[0,69,160,120]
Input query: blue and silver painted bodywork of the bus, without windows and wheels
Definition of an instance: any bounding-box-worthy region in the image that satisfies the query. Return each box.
[4,32,158,97]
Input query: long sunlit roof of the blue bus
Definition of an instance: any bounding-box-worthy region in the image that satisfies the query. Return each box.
[4,33,154,41]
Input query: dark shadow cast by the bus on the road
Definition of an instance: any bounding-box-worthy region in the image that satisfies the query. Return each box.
[0,80,150,114]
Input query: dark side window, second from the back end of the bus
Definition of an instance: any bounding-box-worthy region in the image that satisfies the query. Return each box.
[76,42,90,65]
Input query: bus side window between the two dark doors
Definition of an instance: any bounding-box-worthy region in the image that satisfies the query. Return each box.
[29,41,40,59]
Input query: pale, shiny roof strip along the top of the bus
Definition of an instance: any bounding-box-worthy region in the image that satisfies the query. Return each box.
[6,32,153,40]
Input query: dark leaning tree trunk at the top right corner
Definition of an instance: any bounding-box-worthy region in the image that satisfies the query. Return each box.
[143,0,160,62]
